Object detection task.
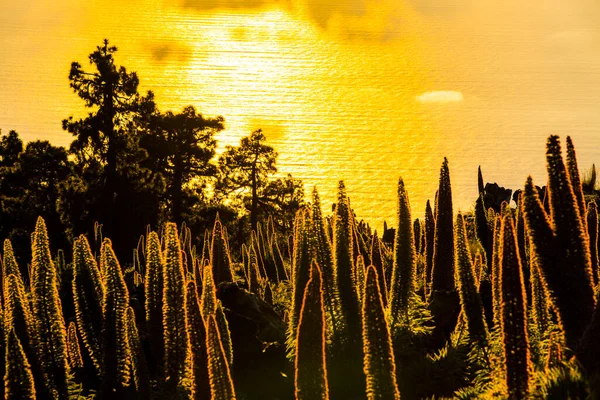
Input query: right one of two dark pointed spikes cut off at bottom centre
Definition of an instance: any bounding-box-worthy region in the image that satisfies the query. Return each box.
[362,266,400,400]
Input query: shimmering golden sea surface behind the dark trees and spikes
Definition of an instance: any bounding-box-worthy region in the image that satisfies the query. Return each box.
[0,0,600,227]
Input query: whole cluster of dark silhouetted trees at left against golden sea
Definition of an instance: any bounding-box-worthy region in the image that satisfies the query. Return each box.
[0,39,304,259]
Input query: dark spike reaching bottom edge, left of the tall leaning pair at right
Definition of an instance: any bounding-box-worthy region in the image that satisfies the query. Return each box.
[500,215,532,400]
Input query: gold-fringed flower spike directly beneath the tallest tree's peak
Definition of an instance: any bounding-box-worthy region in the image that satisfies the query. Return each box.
[100,239,131,393]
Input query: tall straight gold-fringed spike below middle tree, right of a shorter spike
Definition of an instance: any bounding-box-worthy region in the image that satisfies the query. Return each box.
[163,222,188,388]
